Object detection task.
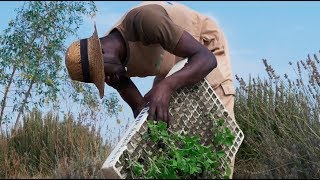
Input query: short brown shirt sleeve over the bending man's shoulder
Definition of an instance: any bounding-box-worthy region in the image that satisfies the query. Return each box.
[119,4,184,53]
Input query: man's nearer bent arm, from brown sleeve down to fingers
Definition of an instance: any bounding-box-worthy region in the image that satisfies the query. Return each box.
[144,31,217,122]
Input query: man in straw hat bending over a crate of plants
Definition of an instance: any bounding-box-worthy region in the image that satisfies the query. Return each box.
[66,1,234,176]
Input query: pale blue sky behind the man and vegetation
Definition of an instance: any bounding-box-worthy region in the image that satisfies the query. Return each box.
[0,1,320,141]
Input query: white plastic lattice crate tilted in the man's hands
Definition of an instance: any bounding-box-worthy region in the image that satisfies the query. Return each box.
[102,60,244,179]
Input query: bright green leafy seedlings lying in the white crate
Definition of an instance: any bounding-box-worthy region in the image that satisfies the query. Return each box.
[130,121,234,179]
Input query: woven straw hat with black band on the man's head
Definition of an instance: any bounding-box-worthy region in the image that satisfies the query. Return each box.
[65,24,105,98]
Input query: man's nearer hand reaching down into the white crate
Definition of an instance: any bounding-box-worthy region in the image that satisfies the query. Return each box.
[144,81,173,125]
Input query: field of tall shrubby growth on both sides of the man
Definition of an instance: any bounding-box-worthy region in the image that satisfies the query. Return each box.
[0,52,320,179]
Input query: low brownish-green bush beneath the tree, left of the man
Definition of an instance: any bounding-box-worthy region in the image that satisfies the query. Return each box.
[0,110,110,178]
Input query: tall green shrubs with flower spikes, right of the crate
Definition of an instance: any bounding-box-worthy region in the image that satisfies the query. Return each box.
[234,52,320,179]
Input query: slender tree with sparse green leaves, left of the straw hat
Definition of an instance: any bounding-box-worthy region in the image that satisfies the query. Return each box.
[0,1,121,132]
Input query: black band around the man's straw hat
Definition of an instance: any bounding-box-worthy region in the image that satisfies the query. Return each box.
[80,39,92,83]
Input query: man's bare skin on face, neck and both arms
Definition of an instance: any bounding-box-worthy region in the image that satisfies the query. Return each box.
[100,30,217,124]
